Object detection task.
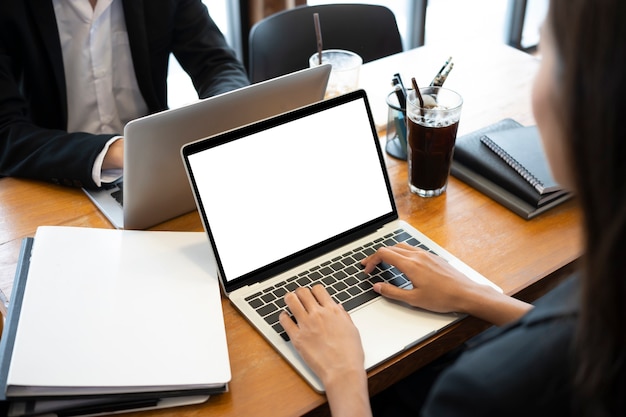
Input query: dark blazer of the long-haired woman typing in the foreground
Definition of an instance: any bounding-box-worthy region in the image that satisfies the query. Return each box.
[422,276,580,417]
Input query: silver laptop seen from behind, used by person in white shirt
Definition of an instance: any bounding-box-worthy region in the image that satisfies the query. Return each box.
[85,65,330,229]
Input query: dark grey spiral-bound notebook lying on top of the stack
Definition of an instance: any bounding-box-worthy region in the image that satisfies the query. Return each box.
[480,126,562,194]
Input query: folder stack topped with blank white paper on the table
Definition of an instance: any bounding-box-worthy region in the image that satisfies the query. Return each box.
[0,227,231,416]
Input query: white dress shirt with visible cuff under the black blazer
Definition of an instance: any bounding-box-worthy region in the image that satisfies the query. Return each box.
[53,0,148,185]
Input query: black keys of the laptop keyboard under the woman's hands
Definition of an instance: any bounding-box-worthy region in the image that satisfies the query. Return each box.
[245,229,434,340]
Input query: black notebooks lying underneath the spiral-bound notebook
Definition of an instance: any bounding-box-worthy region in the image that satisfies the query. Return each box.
[451,119,571,219]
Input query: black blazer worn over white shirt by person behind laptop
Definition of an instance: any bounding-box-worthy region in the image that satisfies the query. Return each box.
[0,0,248,187]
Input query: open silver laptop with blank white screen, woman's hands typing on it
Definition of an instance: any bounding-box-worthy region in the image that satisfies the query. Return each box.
[181,90,497,392]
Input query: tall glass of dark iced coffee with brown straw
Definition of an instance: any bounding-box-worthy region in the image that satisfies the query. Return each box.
[406,87,463,197]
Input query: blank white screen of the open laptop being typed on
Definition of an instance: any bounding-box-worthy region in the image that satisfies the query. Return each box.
[188,94,394,281]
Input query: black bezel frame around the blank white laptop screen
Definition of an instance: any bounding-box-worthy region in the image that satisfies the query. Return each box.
[181,90,398,294]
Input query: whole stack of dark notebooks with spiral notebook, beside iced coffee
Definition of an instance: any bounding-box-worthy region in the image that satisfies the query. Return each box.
[451,119,572,219]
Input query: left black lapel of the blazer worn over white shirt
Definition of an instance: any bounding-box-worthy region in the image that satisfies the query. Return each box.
[24,0,67,124]
